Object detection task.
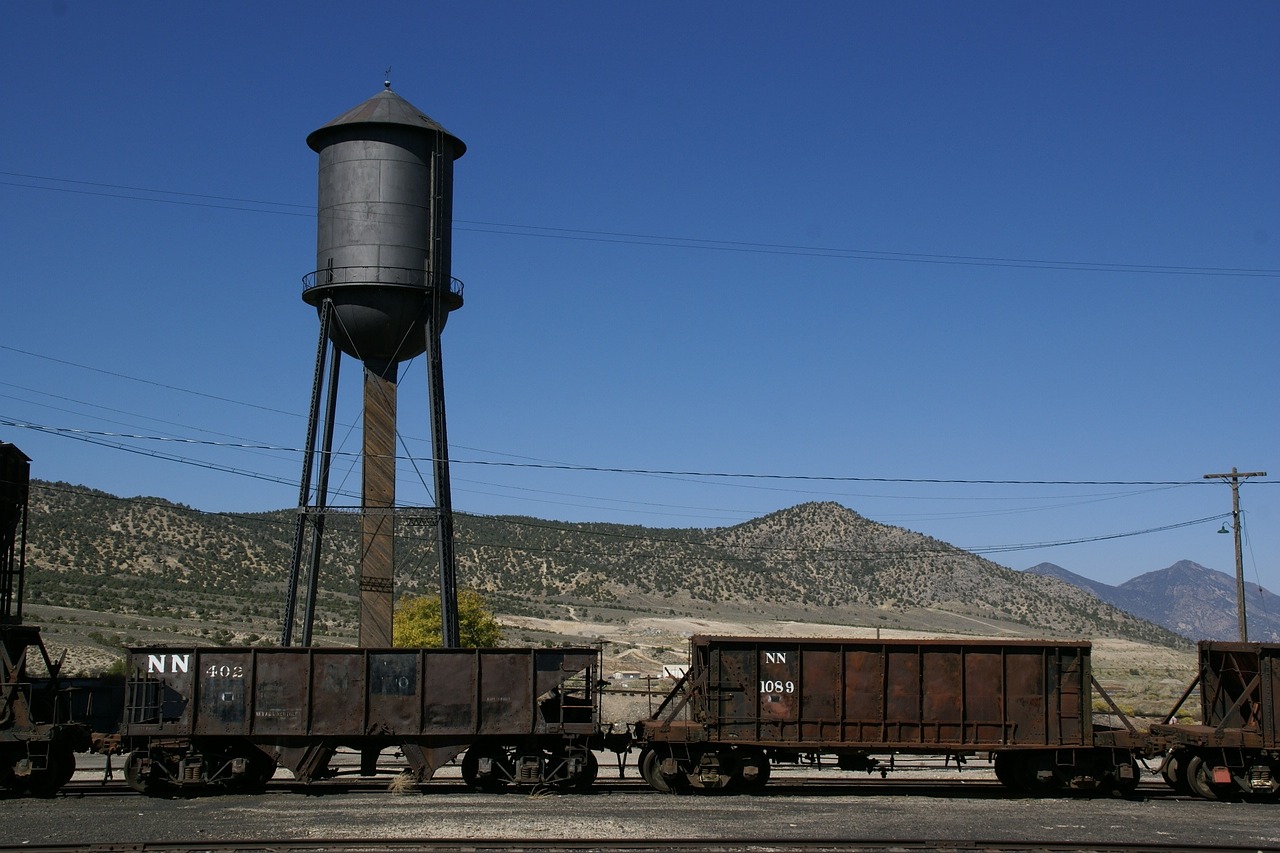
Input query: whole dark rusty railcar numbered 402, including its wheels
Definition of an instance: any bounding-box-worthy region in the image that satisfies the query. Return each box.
[120,647,600,793]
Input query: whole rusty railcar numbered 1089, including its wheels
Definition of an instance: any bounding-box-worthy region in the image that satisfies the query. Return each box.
[636,635,1142,790]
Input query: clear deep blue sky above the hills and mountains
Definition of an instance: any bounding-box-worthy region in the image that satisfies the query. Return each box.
[0,0,1280,594]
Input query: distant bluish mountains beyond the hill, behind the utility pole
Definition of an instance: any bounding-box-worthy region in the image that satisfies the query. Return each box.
[1027,560,1280,643]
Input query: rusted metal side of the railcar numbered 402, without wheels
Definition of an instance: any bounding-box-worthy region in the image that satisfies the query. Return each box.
[123,647,599,740]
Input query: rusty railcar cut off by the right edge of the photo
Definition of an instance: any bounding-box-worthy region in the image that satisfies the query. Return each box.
[1151,640,1280,800]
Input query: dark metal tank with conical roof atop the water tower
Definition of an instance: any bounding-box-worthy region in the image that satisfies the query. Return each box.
[302,86,466,373]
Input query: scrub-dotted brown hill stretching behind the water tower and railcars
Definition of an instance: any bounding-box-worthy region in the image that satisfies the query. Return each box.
[27,480,1184,646]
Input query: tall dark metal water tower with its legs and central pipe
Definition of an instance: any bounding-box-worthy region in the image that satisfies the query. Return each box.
[280,82,466,647]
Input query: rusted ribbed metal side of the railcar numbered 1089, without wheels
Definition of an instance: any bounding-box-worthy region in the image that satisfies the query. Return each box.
[686,637,1092,749]
